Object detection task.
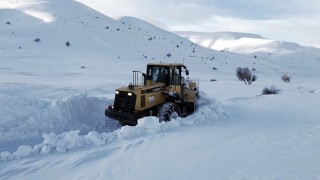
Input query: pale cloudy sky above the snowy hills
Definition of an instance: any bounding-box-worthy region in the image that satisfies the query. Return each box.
[76,0,320,48]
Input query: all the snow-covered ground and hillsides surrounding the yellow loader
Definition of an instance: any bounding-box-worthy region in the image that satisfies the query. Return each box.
[0,0,320,179]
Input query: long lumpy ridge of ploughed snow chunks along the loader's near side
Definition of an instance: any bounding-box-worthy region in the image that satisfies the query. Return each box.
[0,95,225,161]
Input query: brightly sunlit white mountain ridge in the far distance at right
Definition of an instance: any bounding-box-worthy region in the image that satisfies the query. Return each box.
[174,31,320,54]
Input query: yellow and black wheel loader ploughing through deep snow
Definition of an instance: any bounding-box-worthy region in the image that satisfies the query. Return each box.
[105,63,199,126]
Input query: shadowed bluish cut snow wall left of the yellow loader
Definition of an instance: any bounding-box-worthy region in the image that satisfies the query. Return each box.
[0,93,119,150]
